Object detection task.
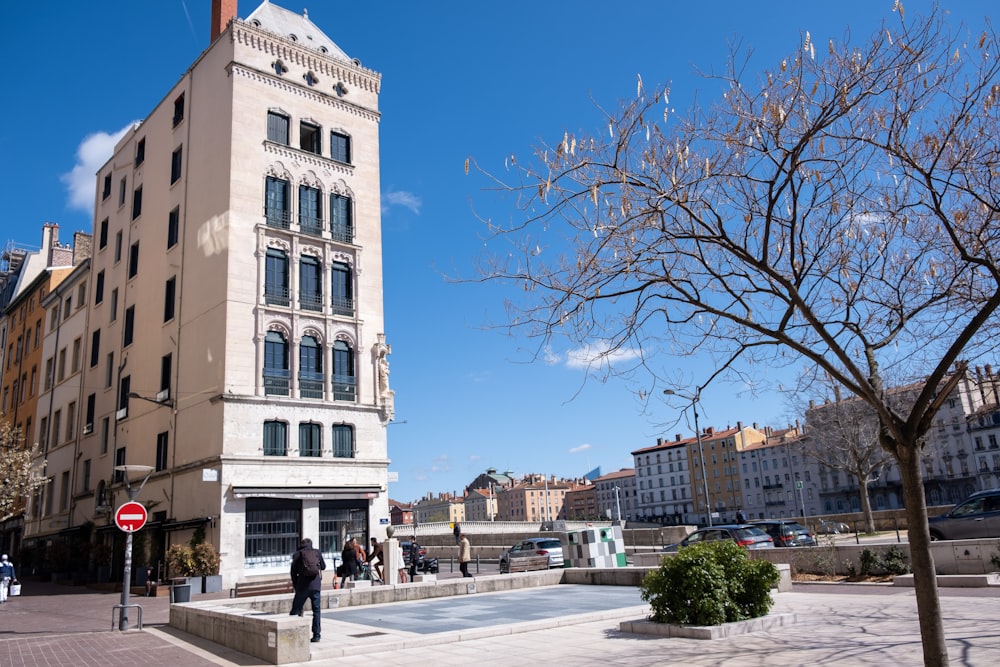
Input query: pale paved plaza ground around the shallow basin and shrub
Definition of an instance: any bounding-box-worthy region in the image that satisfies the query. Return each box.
[0,580,1000,667]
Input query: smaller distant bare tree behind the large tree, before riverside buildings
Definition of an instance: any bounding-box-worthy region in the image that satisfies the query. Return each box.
[803,387,892,533]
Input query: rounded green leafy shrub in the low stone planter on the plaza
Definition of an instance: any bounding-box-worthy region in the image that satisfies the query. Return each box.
[640,540,779,625]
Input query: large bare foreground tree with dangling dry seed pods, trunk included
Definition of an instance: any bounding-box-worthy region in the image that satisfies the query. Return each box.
[481,8,1000,665]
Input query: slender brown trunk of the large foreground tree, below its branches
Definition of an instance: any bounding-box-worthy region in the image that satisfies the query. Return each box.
[899,444,948,667]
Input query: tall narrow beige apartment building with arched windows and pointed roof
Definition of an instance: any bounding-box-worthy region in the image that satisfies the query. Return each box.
[14,0,393,586]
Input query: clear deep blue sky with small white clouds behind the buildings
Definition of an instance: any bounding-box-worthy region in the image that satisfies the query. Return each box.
[0,0,993,501]
